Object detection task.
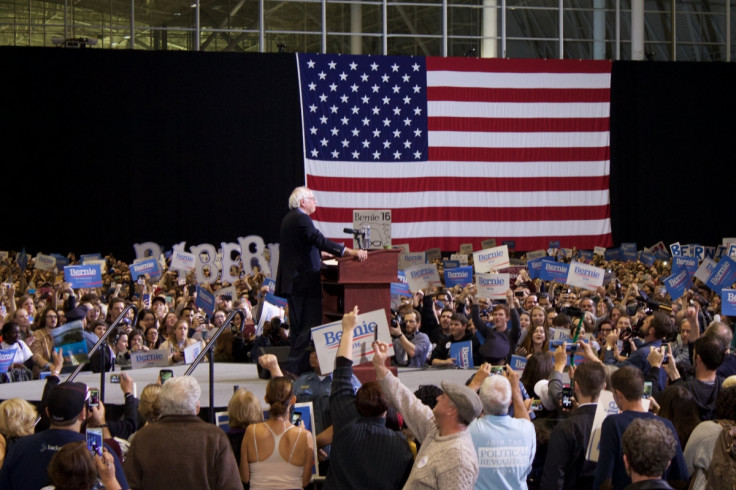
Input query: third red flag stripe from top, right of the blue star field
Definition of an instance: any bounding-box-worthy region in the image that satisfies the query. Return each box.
[427,117,610,133]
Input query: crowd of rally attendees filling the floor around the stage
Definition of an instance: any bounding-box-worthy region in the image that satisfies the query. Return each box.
[0,249,736,489]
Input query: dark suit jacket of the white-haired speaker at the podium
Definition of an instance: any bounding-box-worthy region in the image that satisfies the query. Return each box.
[276,209,345,297]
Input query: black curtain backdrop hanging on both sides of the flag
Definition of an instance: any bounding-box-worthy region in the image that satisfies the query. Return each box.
[0,47,736,261]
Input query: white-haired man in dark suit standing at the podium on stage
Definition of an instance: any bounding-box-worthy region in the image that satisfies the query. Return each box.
[276,187,368,374]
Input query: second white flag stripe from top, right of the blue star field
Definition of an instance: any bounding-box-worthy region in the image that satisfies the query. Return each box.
[427,100,610,119]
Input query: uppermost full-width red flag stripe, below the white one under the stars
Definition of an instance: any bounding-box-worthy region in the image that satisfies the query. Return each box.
[309,175,609,193]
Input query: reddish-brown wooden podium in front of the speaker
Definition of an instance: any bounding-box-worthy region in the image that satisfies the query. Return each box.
[322,249,400,323]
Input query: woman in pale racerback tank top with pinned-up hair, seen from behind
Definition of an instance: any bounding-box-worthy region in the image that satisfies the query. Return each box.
[240,377,314,490]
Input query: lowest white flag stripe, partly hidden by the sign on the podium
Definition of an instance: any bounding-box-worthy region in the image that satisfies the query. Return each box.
[315,219,611,239]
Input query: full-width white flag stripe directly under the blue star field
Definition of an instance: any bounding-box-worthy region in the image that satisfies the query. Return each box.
[305,159,610,179]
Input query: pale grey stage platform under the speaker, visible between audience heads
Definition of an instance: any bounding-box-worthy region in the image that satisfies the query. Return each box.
[0,363,475,410]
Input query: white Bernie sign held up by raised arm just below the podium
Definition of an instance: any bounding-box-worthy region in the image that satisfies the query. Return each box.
[312,310,393,374]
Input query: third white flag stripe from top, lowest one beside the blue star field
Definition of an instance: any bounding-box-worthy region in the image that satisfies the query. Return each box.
[427,131,610,148]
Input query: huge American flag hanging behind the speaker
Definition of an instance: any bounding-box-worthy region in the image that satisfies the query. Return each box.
[297,54,612,251]
